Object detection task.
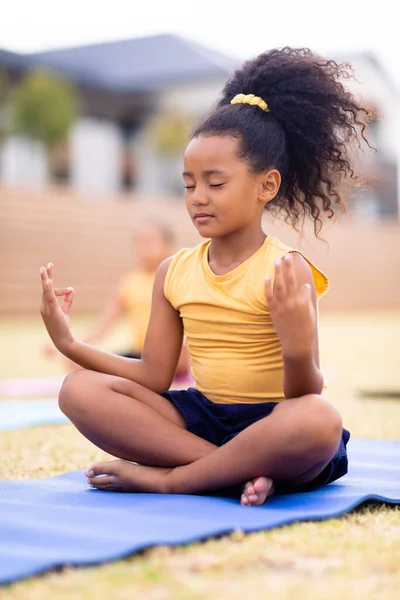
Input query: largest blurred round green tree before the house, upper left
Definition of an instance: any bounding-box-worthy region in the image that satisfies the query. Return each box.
[13,70,77,147]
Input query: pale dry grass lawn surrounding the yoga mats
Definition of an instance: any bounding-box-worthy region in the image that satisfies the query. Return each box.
[0,312,400,600]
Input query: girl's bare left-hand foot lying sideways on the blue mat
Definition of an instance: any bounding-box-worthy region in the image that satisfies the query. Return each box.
[85,460,172,494]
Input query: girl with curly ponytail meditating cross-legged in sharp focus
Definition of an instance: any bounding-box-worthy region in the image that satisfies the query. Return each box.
[41,48,367,505]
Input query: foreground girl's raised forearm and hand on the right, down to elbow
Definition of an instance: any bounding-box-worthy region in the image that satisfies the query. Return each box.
[266,253,324,398]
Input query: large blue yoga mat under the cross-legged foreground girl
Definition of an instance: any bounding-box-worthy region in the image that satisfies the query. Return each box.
[0,439,400,583]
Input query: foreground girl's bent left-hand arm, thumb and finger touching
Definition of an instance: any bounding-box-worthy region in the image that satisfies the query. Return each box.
[41,258,183,393]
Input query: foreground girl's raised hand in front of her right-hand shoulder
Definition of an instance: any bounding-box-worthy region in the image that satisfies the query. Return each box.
[265,254,317,358]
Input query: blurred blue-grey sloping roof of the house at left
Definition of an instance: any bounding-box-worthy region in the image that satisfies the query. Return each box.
[26,34,238,93]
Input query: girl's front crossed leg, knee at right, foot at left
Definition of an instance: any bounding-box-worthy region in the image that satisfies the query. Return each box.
[87,395,342,502]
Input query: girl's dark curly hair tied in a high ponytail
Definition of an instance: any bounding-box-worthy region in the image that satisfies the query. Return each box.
[193,47,371,235]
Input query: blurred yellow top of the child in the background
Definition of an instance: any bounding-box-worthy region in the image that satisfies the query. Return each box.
[118,271,155,353]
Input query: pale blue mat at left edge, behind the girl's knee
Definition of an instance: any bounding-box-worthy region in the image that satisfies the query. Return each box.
[0,400,68,431]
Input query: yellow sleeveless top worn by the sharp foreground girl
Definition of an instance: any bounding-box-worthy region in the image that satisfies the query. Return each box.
[164,236,329,404]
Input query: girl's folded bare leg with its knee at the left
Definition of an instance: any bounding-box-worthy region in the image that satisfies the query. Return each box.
[59,370,216,467]
